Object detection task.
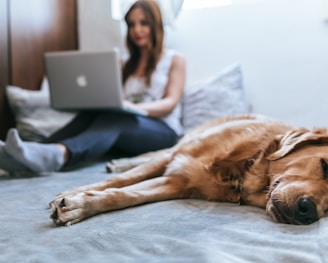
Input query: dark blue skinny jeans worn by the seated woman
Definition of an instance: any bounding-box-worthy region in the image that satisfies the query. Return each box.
[46,111,178,166]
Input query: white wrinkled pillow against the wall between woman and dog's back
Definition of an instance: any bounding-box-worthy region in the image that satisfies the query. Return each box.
[182,64,248,130]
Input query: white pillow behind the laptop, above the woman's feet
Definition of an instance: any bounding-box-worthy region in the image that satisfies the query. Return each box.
[6,78,75,141]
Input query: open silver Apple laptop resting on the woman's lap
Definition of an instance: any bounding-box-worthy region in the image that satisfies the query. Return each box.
[44,49,146,115]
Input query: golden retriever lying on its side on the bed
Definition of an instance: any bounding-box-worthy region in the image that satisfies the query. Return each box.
[50,115,328,225]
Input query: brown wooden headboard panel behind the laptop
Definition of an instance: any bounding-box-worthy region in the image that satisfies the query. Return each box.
[0,0,78,140]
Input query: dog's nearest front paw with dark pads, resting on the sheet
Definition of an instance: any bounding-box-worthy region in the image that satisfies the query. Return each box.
[49,192,92,226]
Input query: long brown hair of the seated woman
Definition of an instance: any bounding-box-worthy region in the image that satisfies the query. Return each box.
[122,0,164,86]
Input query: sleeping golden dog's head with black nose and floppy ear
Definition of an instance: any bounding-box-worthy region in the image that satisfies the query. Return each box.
[266,129,328,225]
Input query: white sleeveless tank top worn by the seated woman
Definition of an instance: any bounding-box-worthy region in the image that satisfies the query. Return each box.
[124,49,183,135]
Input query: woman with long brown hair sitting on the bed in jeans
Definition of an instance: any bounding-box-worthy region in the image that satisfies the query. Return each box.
[0,0,185,175]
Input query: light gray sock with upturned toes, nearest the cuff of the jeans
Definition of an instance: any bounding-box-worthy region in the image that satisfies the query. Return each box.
[5,129,64,172]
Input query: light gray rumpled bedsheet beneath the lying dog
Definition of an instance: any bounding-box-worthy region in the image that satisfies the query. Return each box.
[0,163,328,263]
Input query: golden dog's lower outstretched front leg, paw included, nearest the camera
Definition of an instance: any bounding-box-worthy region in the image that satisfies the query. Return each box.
[51,176,187,225]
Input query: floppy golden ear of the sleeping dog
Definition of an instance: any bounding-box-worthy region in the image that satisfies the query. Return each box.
[267,128,328,161]
